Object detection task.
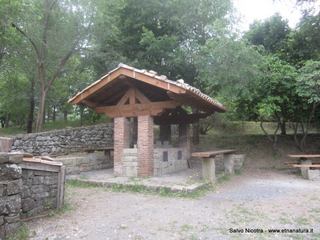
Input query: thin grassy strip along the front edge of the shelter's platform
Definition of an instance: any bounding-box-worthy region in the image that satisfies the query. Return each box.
[66,180,213,198]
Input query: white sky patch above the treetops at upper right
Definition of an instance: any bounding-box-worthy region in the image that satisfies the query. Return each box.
[233,0,320,31]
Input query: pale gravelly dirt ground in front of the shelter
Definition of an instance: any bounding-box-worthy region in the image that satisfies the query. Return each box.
[28,171,320,240]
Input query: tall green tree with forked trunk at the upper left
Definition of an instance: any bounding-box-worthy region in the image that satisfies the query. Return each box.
[12,0,90,131]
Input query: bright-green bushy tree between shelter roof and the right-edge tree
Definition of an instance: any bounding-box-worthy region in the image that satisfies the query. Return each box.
[235,56,298,142]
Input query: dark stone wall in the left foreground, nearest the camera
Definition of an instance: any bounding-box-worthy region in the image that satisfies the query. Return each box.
[0,153,65,239]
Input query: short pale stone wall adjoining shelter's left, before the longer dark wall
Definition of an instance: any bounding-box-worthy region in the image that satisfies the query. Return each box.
[55,151,113,174]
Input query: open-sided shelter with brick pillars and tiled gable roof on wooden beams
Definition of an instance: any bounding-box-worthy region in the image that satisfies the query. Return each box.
[69,64,225,177]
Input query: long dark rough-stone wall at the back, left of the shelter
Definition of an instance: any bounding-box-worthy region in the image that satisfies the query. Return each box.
[9,123,113,155]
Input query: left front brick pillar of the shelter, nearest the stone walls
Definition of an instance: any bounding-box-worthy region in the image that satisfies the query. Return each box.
[113,117,129,176]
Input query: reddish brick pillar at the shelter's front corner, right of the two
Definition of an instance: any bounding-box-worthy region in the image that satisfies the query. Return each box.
[138,116,153,177]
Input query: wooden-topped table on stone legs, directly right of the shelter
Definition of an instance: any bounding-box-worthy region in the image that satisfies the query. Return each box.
[191,149,236,183]
